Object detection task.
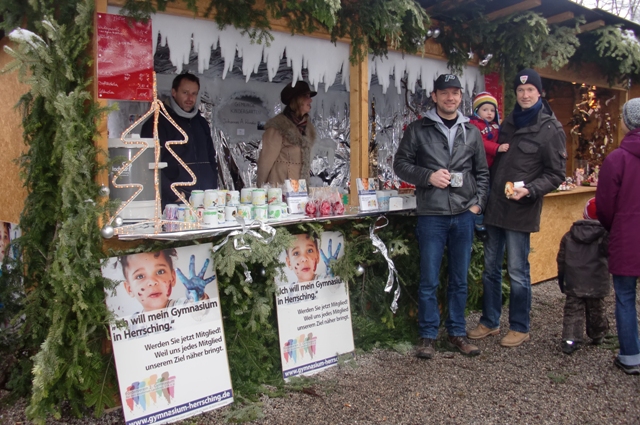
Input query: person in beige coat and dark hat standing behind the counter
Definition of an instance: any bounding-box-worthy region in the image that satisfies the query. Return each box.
[257,81,317,187]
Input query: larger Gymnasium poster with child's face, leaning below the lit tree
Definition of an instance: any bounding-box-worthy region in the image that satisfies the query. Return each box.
[102,244,233,424]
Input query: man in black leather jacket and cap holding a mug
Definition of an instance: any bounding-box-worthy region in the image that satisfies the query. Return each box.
[393,74,489,359]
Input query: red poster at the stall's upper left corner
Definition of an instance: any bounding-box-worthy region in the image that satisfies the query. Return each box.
[98,13,153,101]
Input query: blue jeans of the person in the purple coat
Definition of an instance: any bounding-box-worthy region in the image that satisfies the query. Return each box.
[613,274,640,366]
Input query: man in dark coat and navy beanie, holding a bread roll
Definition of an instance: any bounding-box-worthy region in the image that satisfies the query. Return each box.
[468,69,567,347]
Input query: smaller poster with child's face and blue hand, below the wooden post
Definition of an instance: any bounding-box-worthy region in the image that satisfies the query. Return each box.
[276,232,354,380]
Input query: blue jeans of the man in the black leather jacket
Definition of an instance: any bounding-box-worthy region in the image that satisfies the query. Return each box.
[416,211,475,339]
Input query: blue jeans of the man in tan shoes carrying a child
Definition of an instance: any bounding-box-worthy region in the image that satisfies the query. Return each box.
[480,226,531,333]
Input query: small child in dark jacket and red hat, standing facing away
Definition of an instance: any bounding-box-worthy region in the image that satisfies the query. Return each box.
[556,198,611,354]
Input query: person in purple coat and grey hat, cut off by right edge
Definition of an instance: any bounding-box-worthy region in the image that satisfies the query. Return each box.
[596,98,640,375]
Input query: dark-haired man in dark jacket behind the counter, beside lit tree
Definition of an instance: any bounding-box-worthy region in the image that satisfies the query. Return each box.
[141,73,218,208]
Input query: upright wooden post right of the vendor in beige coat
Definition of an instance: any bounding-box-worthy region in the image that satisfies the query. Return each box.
[349,53,369,207]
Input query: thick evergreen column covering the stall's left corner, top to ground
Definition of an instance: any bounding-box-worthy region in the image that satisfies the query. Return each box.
[1,0,117,423]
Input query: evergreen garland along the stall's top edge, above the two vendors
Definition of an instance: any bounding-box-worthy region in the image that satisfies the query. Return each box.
[123,0,430,63]
